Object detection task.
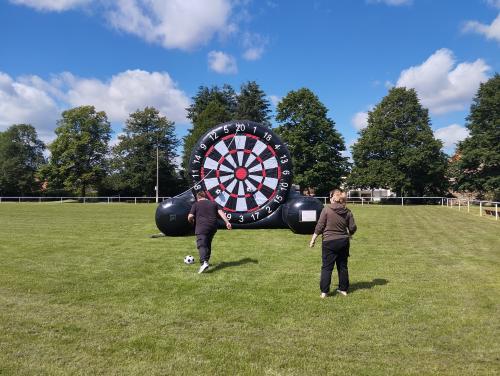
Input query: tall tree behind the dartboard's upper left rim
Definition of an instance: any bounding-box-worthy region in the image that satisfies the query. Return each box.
[182,85,237,170]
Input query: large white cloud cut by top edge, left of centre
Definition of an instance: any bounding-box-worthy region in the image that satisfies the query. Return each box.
[11,0,232,50]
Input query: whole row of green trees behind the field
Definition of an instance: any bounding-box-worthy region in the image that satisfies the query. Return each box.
[0,74,500,200]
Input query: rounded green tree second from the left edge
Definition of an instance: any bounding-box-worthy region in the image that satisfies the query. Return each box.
[40,106,111,197]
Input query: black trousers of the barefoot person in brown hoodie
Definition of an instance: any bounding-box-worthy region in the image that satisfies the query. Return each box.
[319,238,349,293]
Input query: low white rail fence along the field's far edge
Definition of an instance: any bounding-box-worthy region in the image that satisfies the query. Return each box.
[0,196,500,220]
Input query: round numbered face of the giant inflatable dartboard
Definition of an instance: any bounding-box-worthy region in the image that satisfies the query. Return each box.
[190,121,292,223]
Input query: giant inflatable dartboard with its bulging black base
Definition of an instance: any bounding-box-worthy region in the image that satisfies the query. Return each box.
[156,120,323,235]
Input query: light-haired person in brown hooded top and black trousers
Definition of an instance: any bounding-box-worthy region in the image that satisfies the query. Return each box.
[309,189,357,298]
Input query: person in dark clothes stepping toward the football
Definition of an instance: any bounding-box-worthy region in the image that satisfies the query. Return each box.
[188,192,232,274]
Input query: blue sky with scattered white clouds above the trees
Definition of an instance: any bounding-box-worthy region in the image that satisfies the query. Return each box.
[0,0,500,154]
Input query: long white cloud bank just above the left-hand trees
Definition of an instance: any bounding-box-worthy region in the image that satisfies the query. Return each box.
[0,70,189,139]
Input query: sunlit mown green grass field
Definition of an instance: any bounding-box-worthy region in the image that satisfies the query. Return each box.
[0,204,500,375]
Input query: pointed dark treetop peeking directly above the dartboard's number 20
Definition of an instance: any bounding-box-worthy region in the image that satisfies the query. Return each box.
[235,81,271,127]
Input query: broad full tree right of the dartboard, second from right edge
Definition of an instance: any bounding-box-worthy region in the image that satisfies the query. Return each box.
[347,87,447,196]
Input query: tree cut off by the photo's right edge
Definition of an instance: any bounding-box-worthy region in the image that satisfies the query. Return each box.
[456,73,500,200]
